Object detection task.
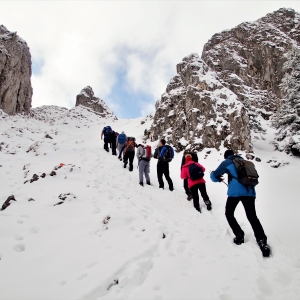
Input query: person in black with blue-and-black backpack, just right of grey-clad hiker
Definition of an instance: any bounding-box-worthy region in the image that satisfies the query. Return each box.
[154,139,174,191]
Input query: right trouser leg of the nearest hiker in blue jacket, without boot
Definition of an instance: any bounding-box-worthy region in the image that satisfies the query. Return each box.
[241,196,267,241]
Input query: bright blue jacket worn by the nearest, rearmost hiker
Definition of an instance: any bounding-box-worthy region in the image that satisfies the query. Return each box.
[210,155,256,197]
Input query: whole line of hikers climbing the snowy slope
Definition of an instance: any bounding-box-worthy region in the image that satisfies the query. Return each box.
[101,126,270,257]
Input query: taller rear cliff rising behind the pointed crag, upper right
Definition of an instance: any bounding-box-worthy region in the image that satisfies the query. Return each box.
[202,8,300,131]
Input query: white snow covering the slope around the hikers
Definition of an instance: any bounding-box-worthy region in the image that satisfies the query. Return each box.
[0,107,300,300]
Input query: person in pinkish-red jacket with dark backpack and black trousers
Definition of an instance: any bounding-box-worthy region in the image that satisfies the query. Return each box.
[180,154,211,212]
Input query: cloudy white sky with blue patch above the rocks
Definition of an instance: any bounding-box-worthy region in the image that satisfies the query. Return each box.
[0,0,300,118]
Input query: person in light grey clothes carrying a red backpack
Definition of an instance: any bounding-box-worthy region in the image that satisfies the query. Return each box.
[136,144,153,186]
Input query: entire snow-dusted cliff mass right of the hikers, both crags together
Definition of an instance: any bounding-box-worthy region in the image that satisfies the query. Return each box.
[152,9,300,152]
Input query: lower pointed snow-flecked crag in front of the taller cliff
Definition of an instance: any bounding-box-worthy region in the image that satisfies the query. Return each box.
[151,54,252,152]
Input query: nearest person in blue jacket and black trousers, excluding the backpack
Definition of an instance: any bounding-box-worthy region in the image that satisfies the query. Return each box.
[210,150,270,257]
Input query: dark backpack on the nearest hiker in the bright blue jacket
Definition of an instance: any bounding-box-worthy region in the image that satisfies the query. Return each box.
[232,158,259,187]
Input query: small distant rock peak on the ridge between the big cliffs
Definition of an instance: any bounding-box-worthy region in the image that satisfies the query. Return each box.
[76,86,118,120]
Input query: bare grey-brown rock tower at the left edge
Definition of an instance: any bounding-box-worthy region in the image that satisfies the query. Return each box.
[0,25,32,115]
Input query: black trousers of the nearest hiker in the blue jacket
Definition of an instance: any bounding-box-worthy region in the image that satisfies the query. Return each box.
[225,196,267,241]
